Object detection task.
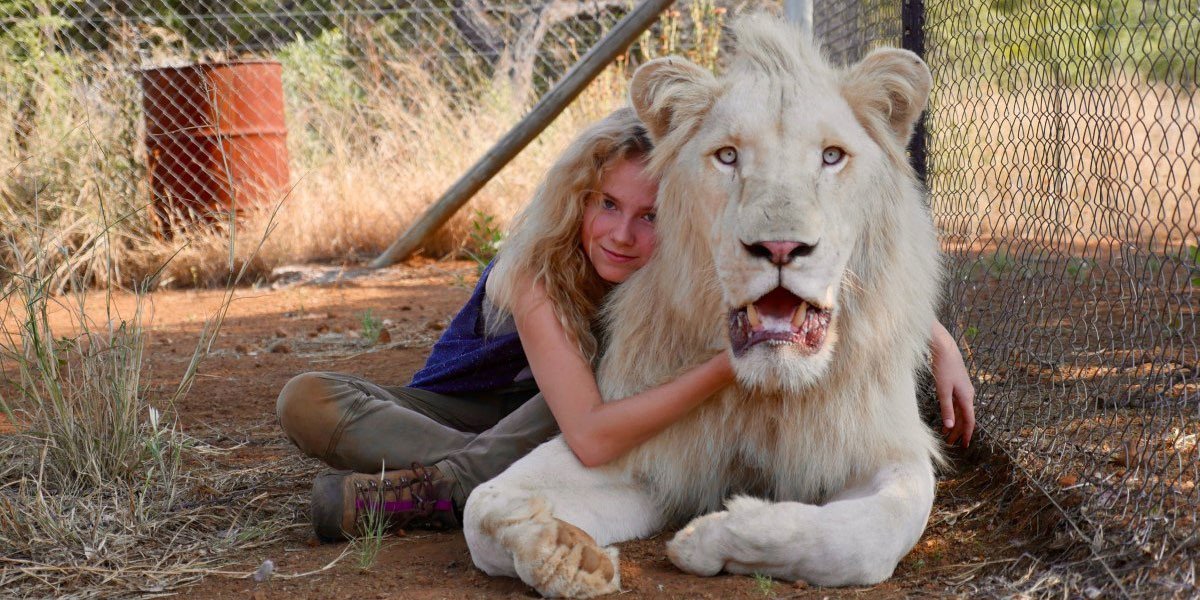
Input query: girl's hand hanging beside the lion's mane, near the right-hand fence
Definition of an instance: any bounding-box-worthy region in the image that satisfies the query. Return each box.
[930,323,974,448]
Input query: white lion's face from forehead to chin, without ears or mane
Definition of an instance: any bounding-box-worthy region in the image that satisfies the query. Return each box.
[700,78,886,386]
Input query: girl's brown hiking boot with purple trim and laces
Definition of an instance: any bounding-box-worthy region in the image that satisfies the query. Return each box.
[311,463,458,541]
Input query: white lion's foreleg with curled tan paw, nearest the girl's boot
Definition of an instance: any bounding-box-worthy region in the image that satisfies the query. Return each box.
[463,438,662,598]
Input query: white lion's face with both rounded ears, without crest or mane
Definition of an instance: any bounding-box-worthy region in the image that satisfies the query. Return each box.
[634,22,928,390]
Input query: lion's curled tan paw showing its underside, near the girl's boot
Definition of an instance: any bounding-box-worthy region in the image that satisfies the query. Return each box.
[515,518,620,598]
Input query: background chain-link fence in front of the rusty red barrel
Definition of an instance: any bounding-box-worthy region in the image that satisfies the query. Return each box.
[0,0,725,289]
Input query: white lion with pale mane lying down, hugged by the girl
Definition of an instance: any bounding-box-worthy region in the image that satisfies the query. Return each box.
[464,16,940,598]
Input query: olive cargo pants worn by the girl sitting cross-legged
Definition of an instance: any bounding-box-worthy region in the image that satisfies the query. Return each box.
[275,372,558,510]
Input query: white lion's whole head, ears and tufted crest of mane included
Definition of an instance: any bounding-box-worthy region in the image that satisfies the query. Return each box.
[631,16,936,390]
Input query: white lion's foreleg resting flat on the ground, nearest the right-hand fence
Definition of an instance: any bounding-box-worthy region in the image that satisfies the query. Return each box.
[667,462,934,586]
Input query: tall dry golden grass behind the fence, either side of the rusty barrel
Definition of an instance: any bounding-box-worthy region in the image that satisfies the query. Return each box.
[0,22,628,292]
